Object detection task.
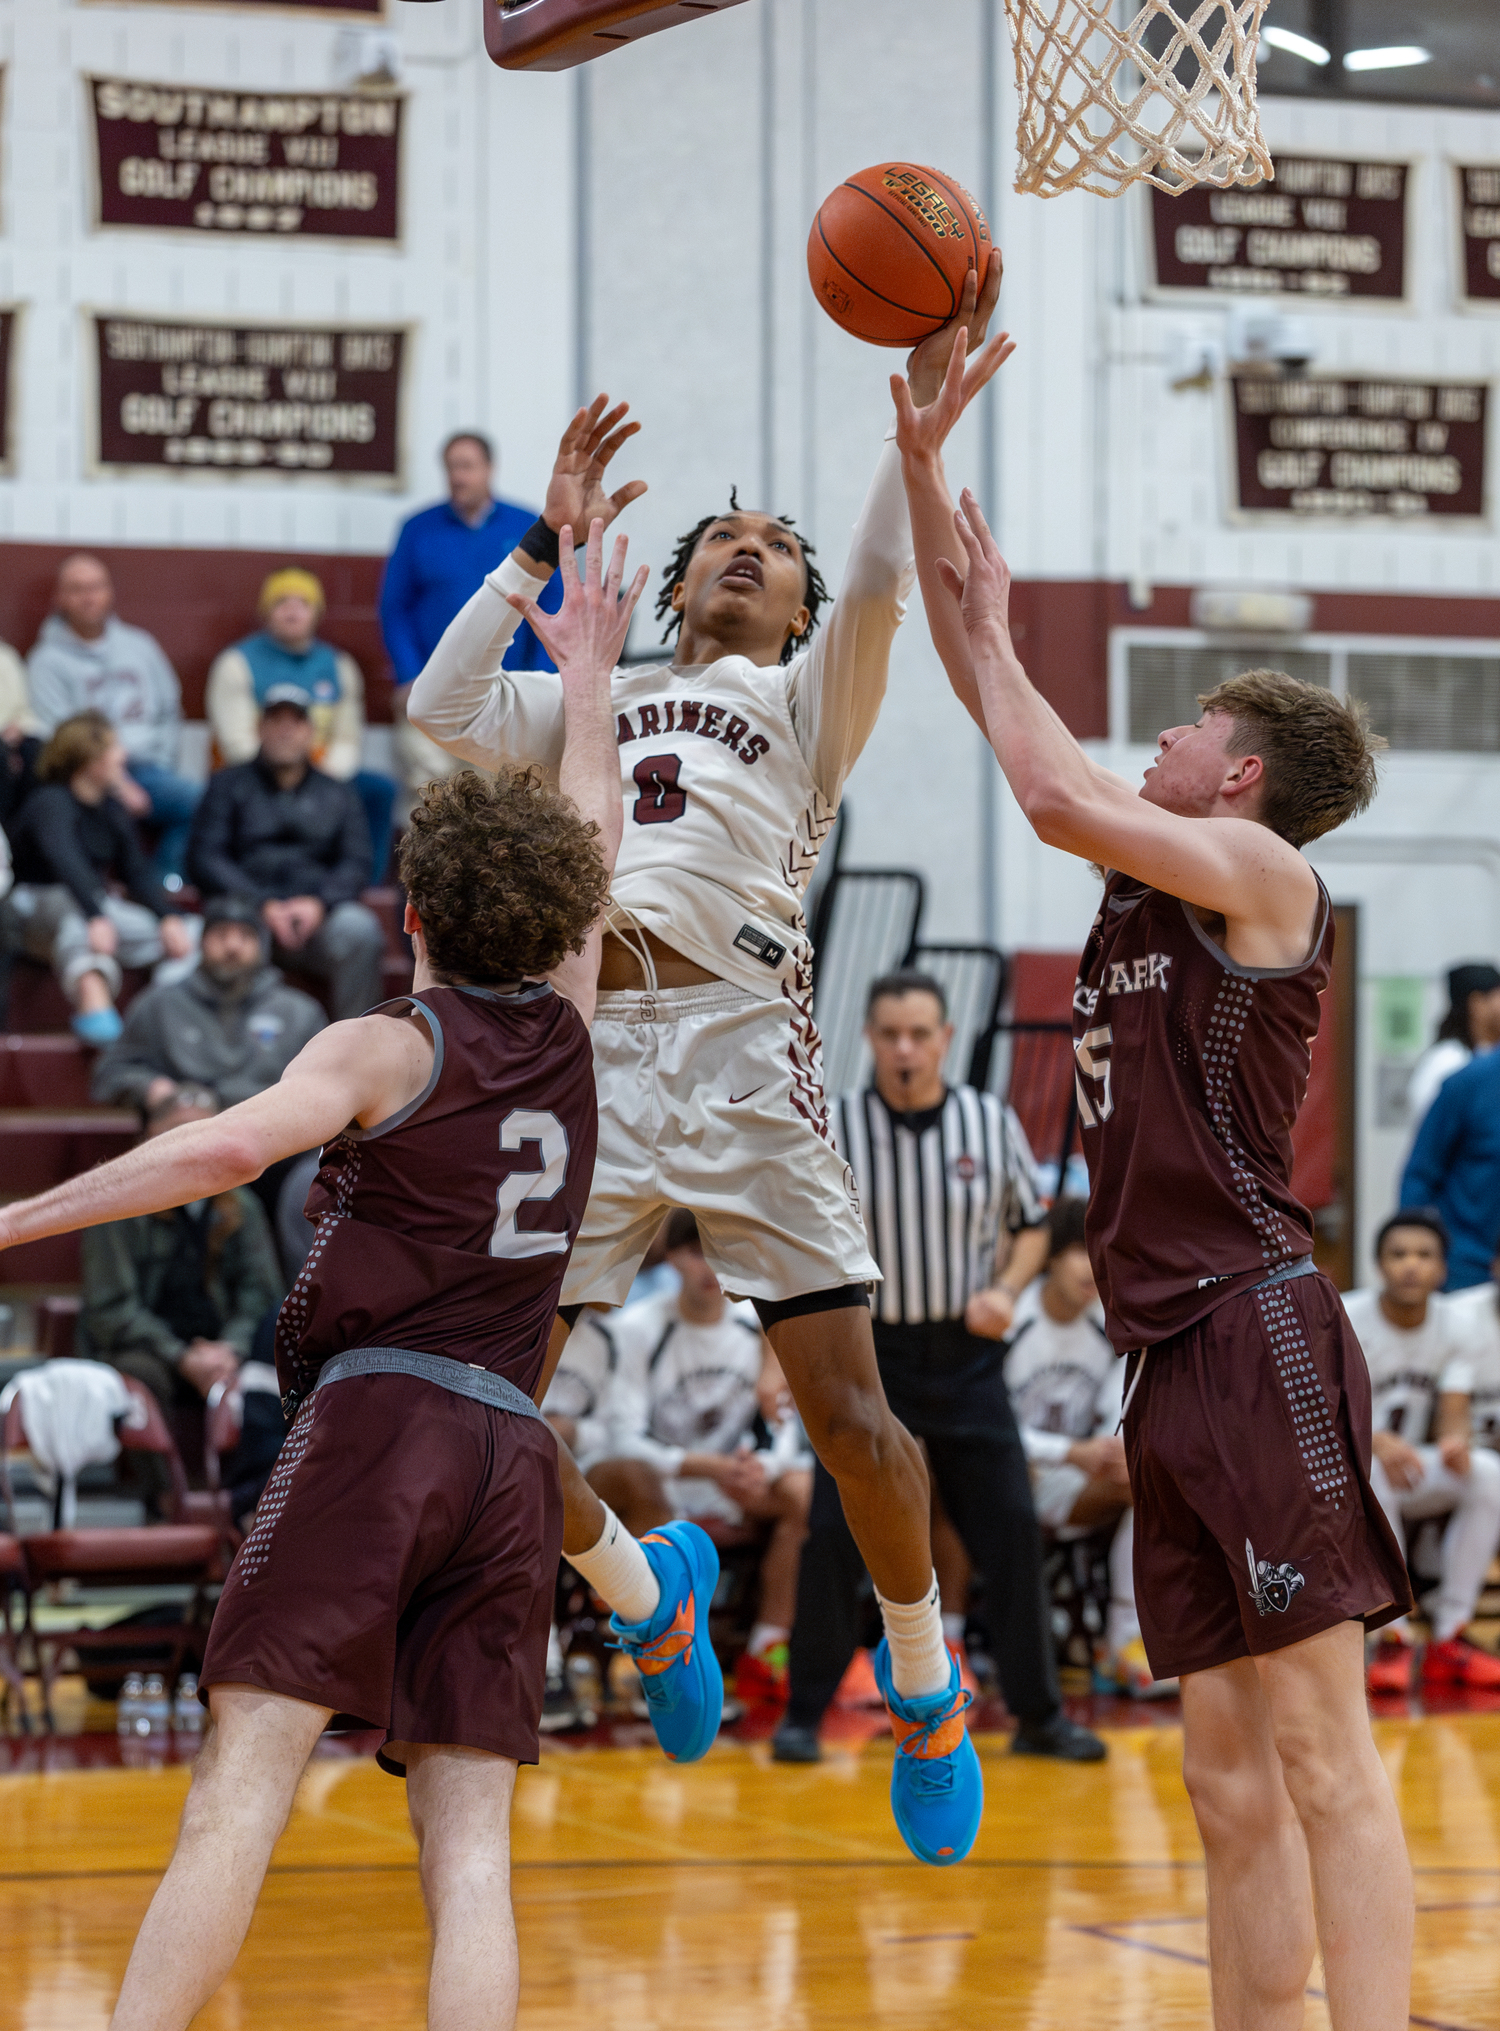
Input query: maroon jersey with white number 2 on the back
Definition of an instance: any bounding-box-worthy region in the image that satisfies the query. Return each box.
[276,985,599,1395]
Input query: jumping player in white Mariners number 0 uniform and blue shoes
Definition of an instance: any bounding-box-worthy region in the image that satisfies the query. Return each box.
[408,278,1009,1862]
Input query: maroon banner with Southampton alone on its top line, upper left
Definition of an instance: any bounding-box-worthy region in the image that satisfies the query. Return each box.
[89,77,402,240]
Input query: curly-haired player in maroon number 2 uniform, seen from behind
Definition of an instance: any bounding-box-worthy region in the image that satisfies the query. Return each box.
[0,526,645,2031]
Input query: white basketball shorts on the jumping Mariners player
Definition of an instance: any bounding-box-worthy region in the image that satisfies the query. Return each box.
[562,981,881,1304]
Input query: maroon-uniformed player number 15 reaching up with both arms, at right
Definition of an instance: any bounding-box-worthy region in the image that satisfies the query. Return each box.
[895,347,1413,2031]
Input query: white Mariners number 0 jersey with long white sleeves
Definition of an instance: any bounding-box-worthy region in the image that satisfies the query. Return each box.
[408,445,915,1001]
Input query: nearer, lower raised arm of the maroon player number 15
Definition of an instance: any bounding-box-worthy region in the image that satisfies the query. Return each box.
[936,489,1319,967]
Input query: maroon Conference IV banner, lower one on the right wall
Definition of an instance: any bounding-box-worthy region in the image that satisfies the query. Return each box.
[1230,376,1490,520]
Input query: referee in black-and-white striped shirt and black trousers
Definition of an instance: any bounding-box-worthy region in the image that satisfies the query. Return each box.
[771,973,1104,1763]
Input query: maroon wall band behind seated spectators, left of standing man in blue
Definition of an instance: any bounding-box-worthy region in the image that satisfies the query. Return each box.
[0,542,390,725]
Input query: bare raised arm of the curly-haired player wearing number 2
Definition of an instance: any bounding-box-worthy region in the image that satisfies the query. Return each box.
[514,518,647,1022]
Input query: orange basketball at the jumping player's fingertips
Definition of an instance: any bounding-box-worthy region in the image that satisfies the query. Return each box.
[808,162,991,345]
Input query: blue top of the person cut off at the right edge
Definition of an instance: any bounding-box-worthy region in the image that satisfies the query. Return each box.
[1401,1050,1500,1290]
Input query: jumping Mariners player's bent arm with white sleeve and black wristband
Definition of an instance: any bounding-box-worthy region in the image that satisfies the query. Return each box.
[406,394,645,770]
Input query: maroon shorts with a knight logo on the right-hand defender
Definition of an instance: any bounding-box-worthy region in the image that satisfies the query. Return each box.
[1124,1275,1411,1678]
